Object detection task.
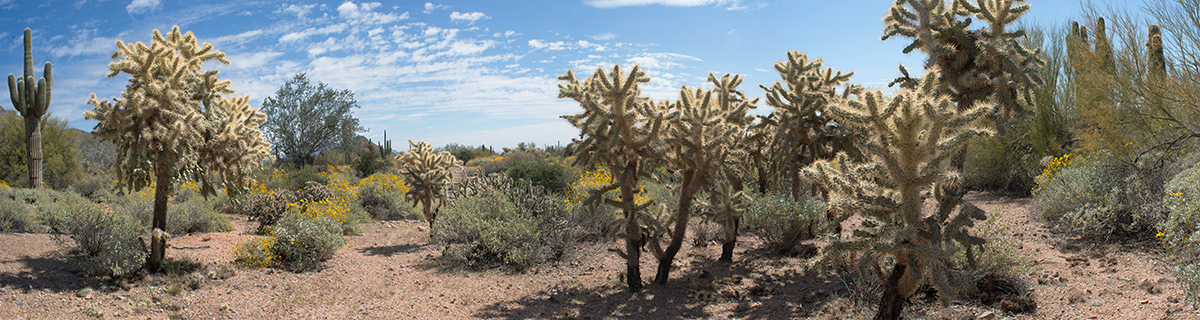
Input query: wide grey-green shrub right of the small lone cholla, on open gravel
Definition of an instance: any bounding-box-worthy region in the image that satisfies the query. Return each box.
[441,175,574,270]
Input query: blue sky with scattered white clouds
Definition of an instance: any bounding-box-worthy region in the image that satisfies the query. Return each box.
[0,0,1080,150]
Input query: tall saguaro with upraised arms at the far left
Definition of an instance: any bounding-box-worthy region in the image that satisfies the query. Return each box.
[8,28,54,188]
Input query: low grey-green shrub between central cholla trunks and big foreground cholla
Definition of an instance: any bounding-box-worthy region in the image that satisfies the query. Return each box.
[742,193,826,253]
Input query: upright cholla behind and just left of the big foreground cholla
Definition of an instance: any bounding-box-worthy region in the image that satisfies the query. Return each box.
[760,50,862,199]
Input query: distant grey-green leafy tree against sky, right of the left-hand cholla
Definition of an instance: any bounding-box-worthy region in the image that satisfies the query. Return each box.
[263,73,364,165]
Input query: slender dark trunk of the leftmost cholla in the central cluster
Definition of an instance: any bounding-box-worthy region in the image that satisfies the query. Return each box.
[620,155,644,292]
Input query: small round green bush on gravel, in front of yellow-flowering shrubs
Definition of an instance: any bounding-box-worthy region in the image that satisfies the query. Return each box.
[271,215,346,272]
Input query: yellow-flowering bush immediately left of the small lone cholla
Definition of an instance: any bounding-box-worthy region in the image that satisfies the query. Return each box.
[359,174,416,219]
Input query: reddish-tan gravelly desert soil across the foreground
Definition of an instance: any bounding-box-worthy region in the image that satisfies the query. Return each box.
[0,194,1200,319]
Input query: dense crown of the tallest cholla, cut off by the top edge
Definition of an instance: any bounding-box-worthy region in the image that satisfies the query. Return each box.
[883,0,1044,137]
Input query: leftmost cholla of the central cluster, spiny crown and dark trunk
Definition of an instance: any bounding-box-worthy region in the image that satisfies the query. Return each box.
[558,65,668,291]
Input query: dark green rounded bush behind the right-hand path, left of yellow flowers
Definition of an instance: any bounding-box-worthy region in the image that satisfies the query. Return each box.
[962,133,1043,195]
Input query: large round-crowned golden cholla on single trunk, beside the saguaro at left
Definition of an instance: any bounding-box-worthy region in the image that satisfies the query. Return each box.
[84,26,269,271]
